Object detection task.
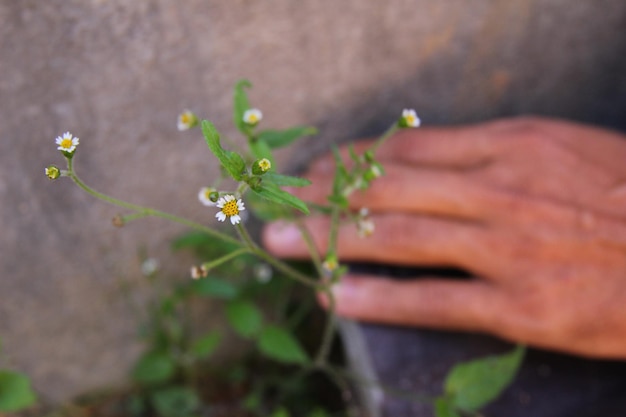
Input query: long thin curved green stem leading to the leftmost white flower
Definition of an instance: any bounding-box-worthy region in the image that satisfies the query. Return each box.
[67,158,241,246]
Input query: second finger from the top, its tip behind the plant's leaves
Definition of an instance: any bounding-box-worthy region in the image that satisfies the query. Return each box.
[296,164,494,220]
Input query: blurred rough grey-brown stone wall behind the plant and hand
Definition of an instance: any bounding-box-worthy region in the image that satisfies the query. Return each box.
[0,0,626,400]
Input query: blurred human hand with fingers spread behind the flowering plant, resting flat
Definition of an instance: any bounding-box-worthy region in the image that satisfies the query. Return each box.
[263,118,626,359]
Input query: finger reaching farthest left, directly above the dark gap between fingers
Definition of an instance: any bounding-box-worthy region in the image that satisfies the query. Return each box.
[263,213,486,274]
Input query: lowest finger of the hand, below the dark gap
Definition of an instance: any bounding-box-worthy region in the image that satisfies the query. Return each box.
[320,275,503,331]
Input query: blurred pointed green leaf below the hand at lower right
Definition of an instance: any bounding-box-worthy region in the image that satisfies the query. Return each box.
[444,346,524,412]
